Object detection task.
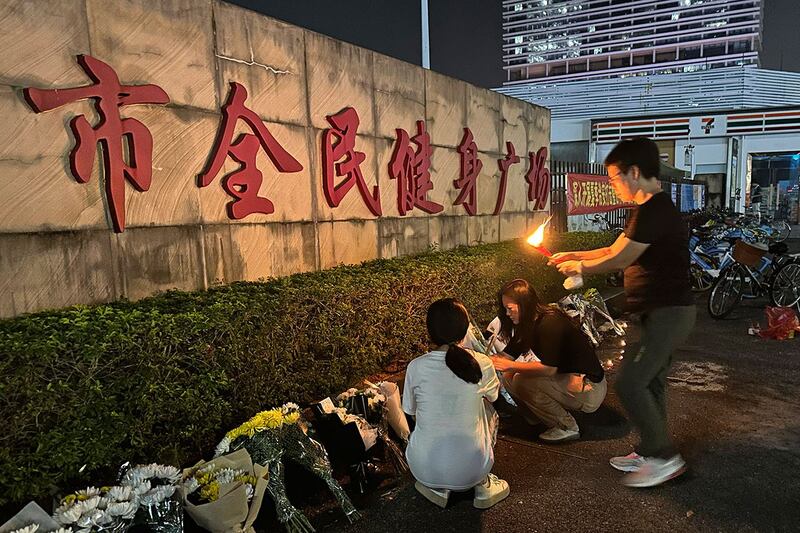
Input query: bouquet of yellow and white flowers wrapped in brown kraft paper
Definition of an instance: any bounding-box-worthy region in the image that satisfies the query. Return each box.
[180,449,268,533]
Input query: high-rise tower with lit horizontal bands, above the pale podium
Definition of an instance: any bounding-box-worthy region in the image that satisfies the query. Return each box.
[503,0,762,86]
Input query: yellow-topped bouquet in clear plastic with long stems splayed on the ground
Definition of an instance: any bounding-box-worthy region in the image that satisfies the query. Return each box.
[216,403,360,533]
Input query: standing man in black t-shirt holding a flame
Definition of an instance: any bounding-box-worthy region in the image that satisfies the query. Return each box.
[551,138,696,487]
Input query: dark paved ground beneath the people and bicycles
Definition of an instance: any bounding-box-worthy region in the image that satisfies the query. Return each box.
[315,262,800,533]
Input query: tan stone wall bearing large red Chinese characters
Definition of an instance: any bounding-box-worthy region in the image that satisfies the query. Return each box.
[0,0,550,317]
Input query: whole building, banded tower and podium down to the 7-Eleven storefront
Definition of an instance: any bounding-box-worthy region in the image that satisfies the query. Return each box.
[498,0,800,224]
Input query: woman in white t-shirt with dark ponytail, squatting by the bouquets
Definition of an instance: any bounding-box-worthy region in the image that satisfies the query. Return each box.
[403,298,509,509]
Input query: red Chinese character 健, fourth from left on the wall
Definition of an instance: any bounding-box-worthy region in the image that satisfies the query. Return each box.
[389,120,443,215]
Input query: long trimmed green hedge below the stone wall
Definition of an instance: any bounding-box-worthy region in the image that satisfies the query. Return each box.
[0,233,610,505]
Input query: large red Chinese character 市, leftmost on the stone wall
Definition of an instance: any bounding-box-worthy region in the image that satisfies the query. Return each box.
[23,55,169,233]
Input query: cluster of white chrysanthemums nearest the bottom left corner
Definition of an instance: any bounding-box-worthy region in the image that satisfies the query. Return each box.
[53,487,139,533]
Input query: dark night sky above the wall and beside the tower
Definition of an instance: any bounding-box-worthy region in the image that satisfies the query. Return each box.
[228,0,800,88]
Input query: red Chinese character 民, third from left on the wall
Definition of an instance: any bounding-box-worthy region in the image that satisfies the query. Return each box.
[322,107,381,217]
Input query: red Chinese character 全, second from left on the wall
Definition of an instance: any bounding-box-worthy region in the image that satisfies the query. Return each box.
[197,81,303,220]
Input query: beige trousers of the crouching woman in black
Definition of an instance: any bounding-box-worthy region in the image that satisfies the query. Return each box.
[503,373,608,430]
